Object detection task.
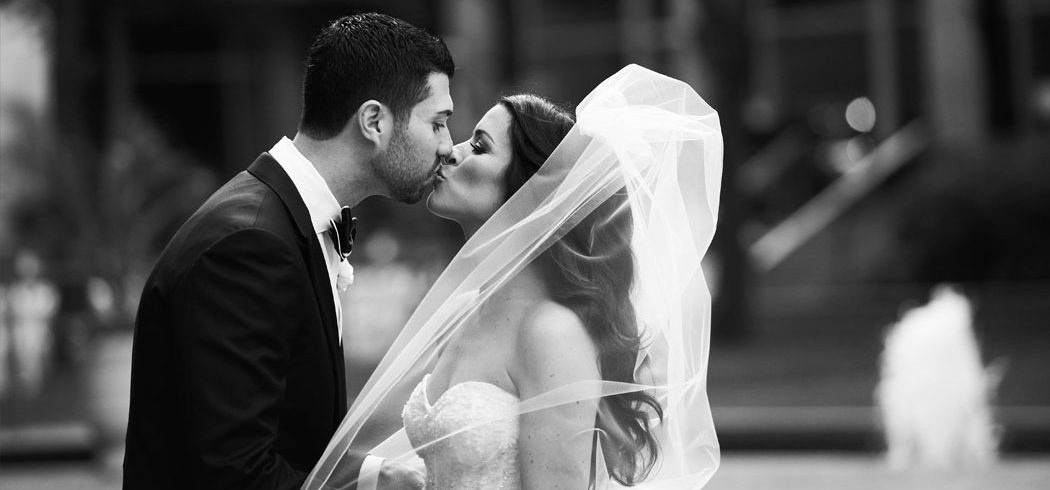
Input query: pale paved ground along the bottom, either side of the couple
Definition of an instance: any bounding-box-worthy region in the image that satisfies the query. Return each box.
[0,453,1050,490]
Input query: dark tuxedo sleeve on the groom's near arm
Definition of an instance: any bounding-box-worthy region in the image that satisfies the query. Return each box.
[173,229,316,489]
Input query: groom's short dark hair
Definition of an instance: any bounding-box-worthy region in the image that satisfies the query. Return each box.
[299,13,456,140]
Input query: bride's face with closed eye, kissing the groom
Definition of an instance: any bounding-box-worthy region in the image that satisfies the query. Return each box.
[426,104,512,228]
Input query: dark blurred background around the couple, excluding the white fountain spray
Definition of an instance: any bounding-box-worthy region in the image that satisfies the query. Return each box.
[0,0,1050,489]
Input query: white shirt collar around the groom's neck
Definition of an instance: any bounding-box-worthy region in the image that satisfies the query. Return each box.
[270,136,339,233]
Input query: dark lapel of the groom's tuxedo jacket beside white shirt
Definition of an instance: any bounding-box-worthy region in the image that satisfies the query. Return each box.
[248,153,347,413]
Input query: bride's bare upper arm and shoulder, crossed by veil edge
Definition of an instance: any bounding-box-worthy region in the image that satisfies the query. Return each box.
[510,303,601,490]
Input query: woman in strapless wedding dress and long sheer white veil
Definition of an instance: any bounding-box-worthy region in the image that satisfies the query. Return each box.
[303,65,722,490]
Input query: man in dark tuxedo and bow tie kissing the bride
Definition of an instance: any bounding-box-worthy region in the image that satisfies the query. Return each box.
[124,14,454,490]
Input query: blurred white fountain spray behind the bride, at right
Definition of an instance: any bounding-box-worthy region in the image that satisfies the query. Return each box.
[876,286,1002,469]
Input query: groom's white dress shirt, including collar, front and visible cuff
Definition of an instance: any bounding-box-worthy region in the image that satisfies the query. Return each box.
[270,137,383,490]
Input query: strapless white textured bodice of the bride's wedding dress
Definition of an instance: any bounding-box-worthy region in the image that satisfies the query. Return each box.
[401,375,521,490]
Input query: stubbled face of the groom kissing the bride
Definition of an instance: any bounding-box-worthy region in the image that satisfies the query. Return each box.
[375,73,453,204]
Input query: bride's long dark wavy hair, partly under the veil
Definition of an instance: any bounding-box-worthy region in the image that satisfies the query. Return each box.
[499,93,664,485]
